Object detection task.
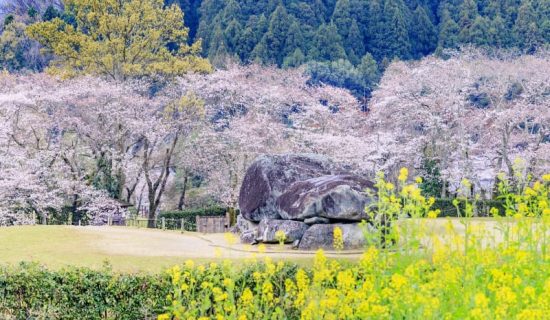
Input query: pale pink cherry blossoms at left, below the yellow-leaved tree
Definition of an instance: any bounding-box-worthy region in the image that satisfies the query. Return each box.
[0,75,203,226]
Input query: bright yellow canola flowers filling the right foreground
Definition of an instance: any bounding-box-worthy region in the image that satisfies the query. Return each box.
[158,170,550,320]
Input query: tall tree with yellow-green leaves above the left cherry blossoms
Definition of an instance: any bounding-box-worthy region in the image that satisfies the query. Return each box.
[27,0,211,80]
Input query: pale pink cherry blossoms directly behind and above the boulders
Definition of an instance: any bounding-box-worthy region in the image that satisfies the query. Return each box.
[180,64,365,207]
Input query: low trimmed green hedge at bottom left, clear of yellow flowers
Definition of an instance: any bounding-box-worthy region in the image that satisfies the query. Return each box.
[0,263,170,320]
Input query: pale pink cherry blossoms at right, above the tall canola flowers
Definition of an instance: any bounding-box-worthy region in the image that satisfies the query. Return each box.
[369,50,550,196]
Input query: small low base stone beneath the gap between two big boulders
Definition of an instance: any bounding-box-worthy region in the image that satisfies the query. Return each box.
[257,219,308,243]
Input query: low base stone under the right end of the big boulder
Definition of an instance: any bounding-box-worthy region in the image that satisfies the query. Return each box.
[298,223,378,250]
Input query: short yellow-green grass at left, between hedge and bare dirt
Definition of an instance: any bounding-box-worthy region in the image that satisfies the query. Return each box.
[0,226,209,272]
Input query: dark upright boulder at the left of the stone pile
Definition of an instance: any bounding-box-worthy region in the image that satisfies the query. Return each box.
[239,154,338,222]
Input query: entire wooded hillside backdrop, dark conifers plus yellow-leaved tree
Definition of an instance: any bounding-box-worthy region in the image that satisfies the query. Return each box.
[0,0,550,97]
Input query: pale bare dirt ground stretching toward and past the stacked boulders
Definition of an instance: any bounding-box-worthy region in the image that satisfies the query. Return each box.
[80,218,532,259]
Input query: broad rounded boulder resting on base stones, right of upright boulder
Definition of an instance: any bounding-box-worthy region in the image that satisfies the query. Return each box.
[277,175,375,221]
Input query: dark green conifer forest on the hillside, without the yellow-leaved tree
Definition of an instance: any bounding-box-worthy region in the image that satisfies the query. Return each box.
[0,0,550,97]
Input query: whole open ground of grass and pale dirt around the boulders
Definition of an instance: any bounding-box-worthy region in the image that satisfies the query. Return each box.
[0,219,512,272]
